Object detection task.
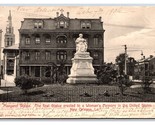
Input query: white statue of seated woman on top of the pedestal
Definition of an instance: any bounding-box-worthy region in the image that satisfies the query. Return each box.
[75,34,88,53]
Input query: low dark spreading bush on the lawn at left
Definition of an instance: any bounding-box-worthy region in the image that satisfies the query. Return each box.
[14,76,44,94]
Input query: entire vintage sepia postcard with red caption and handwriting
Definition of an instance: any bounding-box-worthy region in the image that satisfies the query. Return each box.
[0,5,155,118]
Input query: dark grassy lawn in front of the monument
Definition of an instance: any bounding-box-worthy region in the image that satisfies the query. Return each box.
[0,84,155,102]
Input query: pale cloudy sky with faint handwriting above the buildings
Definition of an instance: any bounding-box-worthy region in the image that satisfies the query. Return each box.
[0,6,155,62]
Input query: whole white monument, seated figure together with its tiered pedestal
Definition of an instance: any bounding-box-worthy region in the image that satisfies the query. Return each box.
[67,34,98,84]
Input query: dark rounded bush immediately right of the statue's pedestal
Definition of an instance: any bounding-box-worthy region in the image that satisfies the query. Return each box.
[96,63,117,84]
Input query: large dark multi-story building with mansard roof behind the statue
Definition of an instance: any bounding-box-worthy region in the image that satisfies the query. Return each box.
[19,11,104,81]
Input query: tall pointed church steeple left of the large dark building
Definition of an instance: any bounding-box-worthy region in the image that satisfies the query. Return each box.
[4,10,15,47]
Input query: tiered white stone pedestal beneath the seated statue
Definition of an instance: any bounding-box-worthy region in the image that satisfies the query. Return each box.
[67,52,98,84]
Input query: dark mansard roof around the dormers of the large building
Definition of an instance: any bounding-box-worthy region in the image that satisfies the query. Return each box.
[20,14,103,30]
